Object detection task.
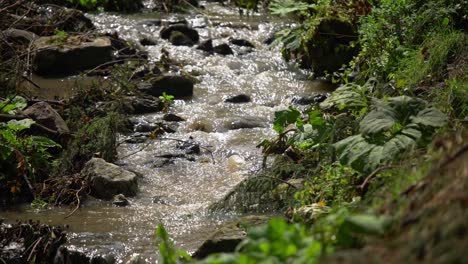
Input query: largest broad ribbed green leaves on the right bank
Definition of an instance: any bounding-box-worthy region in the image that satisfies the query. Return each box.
[334,96,447,172]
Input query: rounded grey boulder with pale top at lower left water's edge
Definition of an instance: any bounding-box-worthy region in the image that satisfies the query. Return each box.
[81,158,138,200]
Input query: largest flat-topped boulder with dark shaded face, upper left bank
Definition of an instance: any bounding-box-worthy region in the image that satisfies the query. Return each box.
[33,36,113,76]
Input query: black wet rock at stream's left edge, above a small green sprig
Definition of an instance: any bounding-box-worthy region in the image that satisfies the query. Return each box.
[138,75,194,98]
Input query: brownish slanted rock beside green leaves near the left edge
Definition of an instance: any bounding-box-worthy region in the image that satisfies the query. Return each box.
[23,102,70,134]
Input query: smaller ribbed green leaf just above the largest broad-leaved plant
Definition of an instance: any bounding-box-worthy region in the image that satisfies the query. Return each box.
[320,83,368,109]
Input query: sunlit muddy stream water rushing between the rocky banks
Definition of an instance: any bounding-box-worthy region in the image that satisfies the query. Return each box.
[1,4,330,263]
